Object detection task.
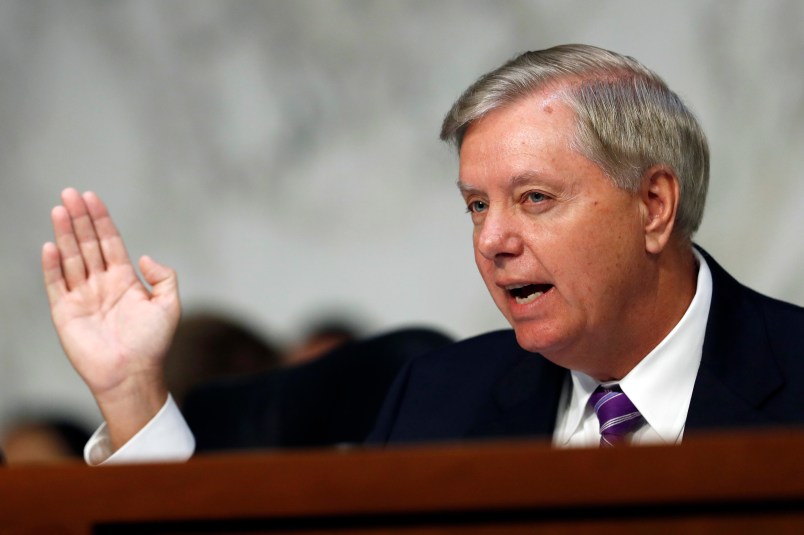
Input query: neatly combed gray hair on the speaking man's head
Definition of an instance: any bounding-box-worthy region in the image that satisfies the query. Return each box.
[441,45,709,238]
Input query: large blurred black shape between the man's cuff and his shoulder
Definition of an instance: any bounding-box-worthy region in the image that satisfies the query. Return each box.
[184,328,452,452]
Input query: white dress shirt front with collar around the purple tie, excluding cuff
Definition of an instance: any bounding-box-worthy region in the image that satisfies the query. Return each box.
[553,250,712,448]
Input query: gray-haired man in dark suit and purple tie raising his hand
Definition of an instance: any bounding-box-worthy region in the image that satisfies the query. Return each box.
[43,45,804,462]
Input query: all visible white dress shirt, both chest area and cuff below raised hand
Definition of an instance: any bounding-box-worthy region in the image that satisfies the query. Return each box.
[84,250,712,465]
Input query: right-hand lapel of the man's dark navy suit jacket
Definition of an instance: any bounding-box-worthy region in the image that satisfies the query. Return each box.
[686,251,783,432]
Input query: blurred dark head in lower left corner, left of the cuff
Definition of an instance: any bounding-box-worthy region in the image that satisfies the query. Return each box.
[3,417,90,465]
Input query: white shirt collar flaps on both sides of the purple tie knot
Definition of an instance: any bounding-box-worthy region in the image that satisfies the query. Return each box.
[566,249,712,444]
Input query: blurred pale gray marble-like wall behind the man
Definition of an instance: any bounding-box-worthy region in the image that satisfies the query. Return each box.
[0,0,804,436]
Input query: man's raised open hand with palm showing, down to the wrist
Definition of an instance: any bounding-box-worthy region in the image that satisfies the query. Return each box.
[42,189,180,448]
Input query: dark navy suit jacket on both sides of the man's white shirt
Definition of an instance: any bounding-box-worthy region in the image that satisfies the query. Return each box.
[368,252,804,444]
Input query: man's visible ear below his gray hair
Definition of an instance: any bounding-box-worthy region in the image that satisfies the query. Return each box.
[639,165,681,254]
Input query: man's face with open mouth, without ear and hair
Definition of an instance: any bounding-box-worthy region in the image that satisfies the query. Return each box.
[459,92,650,373]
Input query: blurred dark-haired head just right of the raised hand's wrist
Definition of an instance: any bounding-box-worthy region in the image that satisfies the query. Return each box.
[165,312,282,405]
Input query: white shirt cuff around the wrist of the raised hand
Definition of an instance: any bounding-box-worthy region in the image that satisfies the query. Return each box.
[84,395,195,466]
